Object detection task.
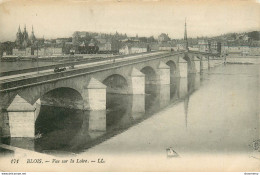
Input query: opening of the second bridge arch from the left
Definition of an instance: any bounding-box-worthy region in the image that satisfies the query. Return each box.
[103,74,128,93]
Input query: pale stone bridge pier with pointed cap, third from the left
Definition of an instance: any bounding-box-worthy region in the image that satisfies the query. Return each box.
[130,68,145,94]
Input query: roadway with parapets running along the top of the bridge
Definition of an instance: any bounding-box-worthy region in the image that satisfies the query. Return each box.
[0,51,177,92]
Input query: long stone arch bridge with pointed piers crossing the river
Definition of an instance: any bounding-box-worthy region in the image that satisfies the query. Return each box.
[0,51,223,137]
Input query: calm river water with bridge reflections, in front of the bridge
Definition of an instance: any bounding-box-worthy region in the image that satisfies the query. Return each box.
[1,64,260,154]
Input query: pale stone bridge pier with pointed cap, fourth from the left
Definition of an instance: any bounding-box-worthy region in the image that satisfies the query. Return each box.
[158,61,171,84]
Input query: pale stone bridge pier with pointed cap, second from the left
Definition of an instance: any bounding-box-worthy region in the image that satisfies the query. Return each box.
[82,78,106,111]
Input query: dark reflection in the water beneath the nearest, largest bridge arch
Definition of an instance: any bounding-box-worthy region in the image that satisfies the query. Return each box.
[35,105,83,152]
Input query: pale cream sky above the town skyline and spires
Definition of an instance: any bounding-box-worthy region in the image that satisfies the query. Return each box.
[0,0,260,42]
